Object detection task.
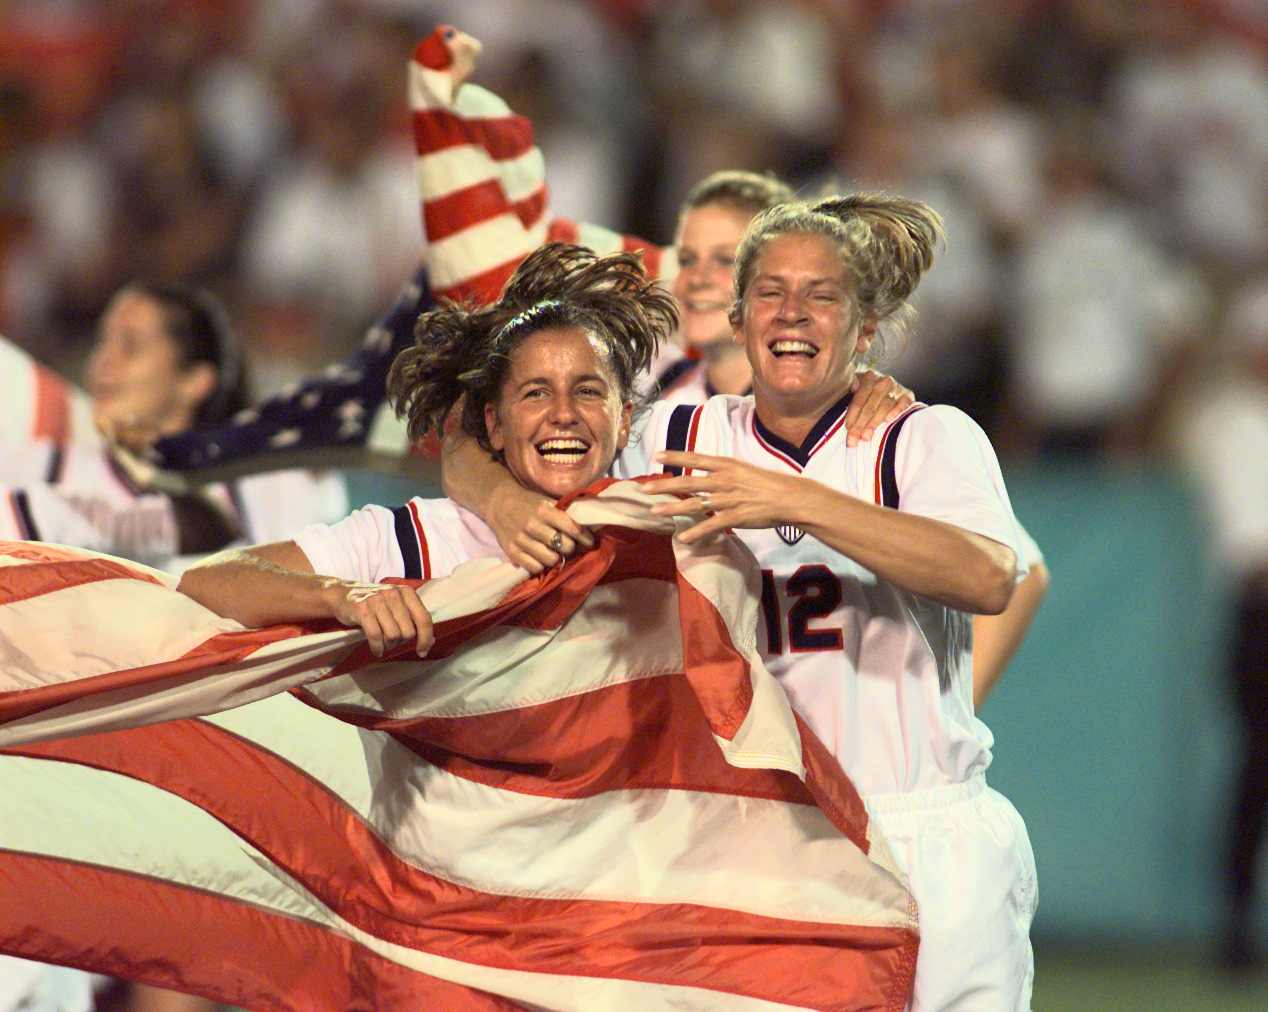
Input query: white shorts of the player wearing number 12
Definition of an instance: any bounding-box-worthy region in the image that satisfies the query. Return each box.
[864,774,1038,1012]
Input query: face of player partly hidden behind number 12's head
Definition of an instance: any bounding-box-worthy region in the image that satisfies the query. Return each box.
[673,202,754,349]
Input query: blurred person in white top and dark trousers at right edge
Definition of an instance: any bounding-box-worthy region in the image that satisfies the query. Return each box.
[1178,278,1268,971]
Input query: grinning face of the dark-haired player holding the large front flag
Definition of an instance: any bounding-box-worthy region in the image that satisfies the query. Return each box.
[484,327,633,498]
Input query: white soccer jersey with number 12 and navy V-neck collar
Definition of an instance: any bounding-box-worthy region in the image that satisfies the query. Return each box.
[616,397,1025,796]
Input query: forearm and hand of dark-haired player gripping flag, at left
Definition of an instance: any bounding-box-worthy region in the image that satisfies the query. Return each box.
[176,542,432,657]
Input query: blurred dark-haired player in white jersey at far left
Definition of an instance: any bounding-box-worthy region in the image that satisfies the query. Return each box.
[0,282,346,569]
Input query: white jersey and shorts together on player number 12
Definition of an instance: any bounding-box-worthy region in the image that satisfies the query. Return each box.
[618,397,1038,1012]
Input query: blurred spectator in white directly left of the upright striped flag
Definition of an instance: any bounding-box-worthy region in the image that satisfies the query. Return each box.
[235,7,422,394]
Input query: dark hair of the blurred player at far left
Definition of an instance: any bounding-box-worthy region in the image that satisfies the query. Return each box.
[117,280,250,429]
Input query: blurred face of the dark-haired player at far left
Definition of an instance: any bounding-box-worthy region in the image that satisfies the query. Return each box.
[87,292,216,435]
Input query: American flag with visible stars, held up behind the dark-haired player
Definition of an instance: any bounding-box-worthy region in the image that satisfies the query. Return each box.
[143,29,673,490]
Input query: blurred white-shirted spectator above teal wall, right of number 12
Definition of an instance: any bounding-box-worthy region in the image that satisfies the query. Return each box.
[1008,114,1211,454]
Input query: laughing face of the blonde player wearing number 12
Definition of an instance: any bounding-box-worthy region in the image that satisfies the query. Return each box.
[735,232,875,431]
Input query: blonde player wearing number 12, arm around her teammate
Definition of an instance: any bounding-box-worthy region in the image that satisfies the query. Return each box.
[446,197,1036,1012]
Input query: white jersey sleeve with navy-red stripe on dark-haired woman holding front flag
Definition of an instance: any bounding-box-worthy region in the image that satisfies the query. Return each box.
[295,497,503,583]
